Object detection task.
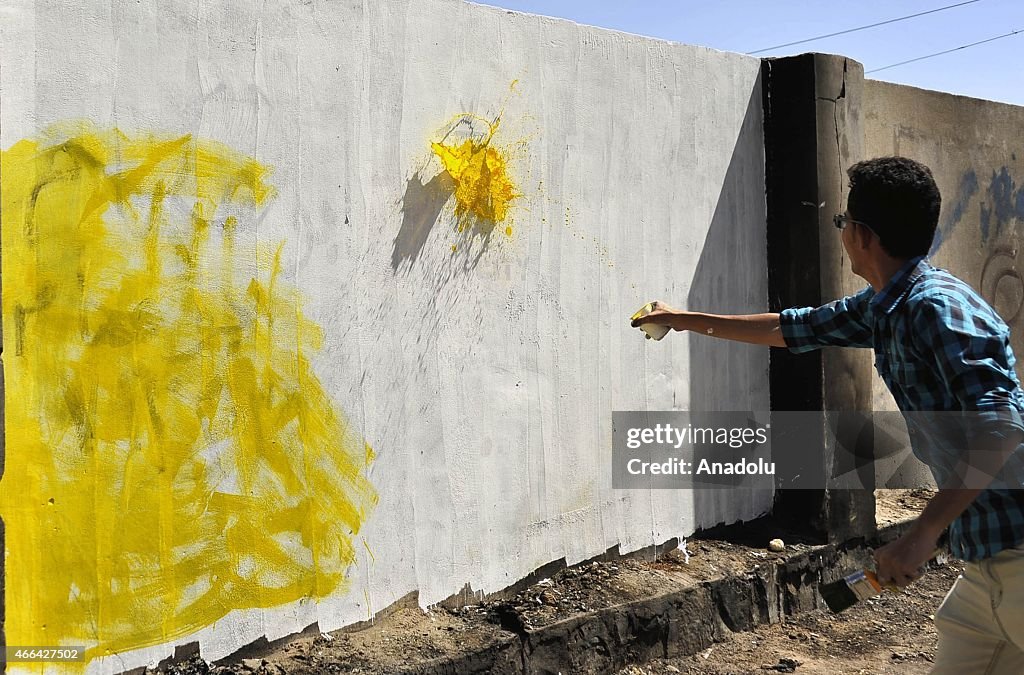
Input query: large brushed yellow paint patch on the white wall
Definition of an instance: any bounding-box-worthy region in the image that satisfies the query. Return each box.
[0,127,377,658]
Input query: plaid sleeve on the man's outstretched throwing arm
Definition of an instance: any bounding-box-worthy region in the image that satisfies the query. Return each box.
[779,286,874,353]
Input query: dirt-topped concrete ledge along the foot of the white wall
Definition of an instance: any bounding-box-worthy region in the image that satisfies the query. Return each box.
[148,521,945,675]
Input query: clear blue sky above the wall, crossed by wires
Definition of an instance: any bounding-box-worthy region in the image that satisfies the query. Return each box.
[482,0,1024,106]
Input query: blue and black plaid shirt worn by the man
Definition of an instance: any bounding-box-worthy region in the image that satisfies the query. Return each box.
[779,257,1024,560]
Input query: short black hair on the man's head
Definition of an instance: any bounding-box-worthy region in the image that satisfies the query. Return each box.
[847,157,942,259]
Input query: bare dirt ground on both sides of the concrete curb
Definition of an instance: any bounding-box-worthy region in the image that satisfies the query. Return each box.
[160,490,946,675]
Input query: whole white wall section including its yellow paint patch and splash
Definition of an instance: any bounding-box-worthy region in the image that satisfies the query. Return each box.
[0,0,770,672]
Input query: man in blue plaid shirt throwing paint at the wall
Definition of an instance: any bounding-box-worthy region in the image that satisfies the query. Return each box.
[633,157,1024,675]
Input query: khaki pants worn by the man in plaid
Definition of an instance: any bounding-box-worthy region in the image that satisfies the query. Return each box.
[931,548,1024,675]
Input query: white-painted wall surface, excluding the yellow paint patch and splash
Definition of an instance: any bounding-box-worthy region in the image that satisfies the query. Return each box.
[0,0,771,671]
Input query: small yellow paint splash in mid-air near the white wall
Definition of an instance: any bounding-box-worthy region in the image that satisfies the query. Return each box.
[430,113,521,236]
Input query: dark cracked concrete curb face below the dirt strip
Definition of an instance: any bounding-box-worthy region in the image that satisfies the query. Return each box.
[398,523,937,675]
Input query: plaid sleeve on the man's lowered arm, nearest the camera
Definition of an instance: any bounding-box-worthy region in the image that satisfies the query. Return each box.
[912,291,1024,432]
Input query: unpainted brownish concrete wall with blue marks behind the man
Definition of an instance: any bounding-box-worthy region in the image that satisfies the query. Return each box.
[864,80,1024,410]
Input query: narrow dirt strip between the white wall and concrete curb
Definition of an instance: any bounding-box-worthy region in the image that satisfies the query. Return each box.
[188,540,798,675]
